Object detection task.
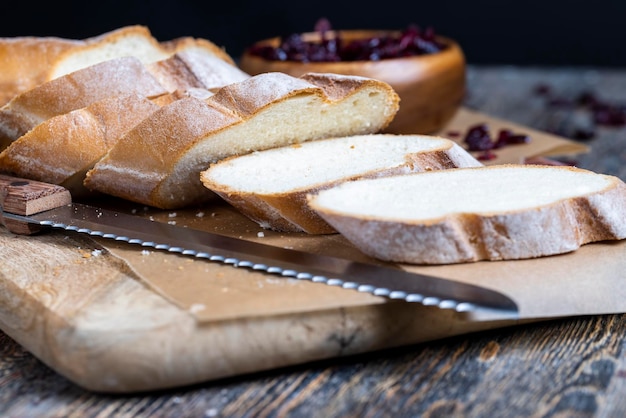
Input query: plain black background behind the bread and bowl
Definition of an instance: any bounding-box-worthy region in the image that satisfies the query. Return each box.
[0,0,626,67]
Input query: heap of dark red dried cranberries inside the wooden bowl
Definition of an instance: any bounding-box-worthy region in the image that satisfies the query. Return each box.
[247,18,445,62]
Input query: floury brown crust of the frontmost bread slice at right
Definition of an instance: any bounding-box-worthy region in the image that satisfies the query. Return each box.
[309,165,626,264]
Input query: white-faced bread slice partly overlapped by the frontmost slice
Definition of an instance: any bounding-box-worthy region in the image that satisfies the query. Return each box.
[201,134,482,234]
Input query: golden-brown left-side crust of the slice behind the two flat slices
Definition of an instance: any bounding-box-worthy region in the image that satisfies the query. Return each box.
[85,97,241,209]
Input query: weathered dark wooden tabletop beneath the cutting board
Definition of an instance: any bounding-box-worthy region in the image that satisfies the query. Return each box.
[0,67,626,417]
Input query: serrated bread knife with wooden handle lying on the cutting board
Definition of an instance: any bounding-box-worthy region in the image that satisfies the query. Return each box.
[0,175,518,319]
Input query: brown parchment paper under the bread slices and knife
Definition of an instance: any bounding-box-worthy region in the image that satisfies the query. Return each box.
[99,109,626,323]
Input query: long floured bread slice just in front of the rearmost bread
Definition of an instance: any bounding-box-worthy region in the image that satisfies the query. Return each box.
[0,47,250,150]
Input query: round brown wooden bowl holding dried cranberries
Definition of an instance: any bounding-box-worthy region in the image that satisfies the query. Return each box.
[239,30,466,134]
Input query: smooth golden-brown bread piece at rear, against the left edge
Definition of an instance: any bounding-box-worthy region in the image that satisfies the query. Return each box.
[0,36,84,106]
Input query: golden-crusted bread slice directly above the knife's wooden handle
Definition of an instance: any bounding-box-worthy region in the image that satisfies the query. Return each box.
[0,93,160,197]
